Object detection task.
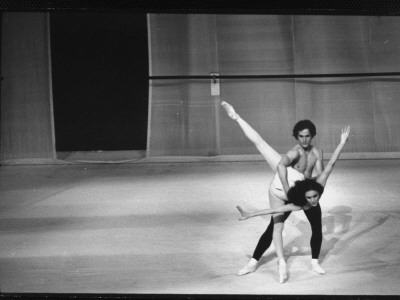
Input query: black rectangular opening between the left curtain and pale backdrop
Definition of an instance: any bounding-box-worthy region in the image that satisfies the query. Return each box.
[50,12,148,151]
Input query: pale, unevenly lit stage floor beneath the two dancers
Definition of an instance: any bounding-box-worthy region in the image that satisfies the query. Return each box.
[0,160,400,295]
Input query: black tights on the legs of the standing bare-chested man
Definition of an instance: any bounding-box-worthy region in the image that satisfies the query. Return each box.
[253,204,322,260]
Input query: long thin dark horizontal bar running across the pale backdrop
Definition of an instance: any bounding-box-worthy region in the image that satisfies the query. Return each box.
[149,72,400,80]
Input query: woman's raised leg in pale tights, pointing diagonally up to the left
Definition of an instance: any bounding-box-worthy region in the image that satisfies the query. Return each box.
[221,101,282,171]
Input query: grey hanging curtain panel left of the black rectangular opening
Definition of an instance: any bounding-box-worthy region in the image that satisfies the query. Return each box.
[1,12,55,163]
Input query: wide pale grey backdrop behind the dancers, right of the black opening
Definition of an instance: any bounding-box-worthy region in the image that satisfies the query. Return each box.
[147,14,400,158]
